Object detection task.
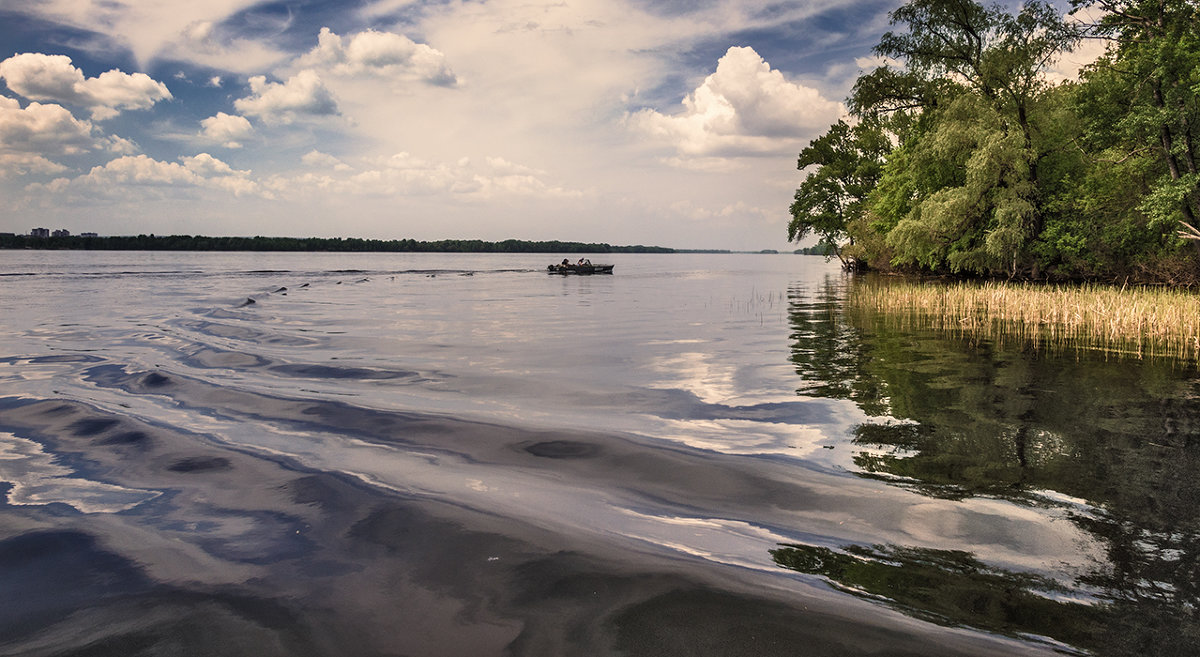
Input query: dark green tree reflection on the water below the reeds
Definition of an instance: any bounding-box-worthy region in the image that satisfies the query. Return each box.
[772,273,1200,656]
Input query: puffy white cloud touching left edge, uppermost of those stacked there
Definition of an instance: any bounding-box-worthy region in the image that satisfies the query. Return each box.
[0,53,172,120]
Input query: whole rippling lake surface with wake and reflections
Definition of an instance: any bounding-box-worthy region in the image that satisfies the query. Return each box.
[0,252,1200,656]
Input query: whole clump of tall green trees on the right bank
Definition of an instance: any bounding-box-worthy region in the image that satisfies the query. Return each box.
[787,0,1200,284]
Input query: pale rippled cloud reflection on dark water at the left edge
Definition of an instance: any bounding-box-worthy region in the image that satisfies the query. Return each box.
[0,433,158,513]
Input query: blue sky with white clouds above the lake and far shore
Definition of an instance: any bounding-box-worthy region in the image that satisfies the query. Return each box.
[0,0,1099,251]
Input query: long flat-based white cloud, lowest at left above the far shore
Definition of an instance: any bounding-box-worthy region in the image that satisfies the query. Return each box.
[28,153,265,198]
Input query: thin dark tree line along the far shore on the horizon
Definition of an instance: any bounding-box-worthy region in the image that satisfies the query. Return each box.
[0,234,674,253]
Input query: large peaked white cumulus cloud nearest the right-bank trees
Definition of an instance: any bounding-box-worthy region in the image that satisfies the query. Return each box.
[628,47,846,156]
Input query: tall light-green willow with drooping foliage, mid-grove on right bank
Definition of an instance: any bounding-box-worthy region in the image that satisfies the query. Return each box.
[851,0,1078,275]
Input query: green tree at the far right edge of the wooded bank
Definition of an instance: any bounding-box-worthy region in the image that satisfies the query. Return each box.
[1079,0,1200,279]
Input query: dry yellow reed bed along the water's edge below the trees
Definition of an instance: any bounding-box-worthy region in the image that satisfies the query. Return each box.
[847,281,1200,361]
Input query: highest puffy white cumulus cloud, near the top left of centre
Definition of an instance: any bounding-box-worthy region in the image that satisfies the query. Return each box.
[299,28,458,86]
